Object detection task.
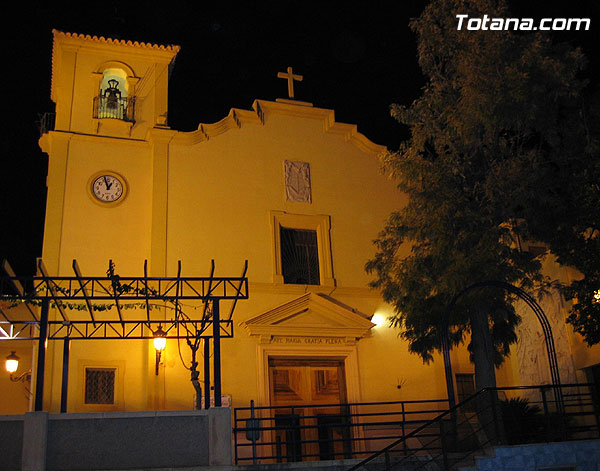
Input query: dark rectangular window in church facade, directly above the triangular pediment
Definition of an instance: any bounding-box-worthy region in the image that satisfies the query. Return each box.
[280,227,320,285]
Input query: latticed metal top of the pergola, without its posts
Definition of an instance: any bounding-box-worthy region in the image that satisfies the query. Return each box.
[0,259,248,341]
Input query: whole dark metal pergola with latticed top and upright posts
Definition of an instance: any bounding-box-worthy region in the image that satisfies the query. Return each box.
[0,259,248,412]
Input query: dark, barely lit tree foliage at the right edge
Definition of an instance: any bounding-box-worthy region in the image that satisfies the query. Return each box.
[520,92,600,345]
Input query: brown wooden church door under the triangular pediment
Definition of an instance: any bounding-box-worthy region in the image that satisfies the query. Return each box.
[269,358,351,462]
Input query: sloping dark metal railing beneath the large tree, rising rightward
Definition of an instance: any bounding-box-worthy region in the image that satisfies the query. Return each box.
[348,384,600,471]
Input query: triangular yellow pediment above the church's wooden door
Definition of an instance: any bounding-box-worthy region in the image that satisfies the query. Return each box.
[241,293,375,345]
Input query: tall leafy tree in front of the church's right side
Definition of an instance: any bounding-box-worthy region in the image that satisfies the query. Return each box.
[366,0,584,389]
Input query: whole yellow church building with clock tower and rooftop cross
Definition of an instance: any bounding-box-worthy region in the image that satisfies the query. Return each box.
[0,31,600,464]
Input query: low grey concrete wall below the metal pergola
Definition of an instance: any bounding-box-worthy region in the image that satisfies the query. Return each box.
[0,408,232,471]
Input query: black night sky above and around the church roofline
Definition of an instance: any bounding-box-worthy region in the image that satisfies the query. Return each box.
[0,0,600,274]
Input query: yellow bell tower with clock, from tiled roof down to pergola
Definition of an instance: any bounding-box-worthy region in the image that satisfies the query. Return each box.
[39,30,179,276]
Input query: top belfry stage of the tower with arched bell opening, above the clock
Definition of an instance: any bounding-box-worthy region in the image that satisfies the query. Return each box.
[51,30,179,139]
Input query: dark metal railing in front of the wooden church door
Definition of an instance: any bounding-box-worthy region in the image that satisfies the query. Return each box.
[233,399,448,464]
